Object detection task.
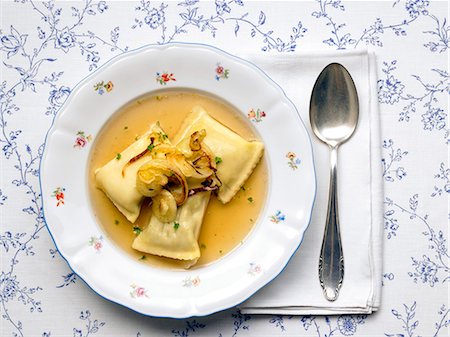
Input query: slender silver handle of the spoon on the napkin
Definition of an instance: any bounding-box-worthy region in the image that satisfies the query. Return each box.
[319,146,344,301]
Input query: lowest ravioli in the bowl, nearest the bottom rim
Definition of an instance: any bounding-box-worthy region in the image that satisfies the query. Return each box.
[132,192,211,258]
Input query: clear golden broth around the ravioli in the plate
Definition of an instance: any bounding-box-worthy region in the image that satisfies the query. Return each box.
[89,91,268,268]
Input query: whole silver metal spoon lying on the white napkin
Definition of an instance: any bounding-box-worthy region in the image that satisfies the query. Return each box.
[309,63,359,301]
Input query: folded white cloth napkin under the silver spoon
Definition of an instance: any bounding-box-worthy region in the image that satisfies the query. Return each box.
[240,51,383,315]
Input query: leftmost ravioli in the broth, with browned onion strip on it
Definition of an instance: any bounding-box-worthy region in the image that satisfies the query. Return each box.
[95,123,171,223]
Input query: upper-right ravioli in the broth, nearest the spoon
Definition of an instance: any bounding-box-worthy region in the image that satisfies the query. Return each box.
[173,106,264,203]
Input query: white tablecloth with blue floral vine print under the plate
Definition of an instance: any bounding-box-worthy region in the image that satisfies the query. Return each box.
[0,0,450,337]
